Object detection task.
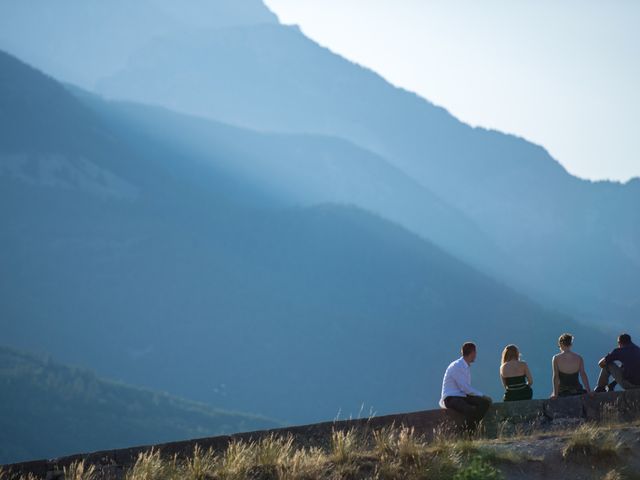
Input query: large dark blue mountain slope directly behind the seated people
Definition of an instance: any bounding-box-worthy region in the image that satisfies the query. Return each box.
[0,49,608,422]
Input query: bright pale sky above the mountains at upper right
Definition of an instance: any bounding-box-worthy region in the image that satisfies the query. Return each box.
[266,0,640,181]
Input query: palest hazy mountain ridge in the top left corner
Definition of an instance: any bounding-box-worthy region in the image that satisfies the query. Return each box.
[0,0,277,88]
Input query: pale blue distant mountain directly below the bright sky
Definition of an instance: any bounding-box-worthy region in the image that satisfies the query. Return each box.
[0,0,640,327]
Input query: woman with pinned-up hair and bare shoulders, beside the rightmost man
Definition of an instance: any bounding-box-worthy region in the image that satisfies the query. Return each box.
[551,333,591,398]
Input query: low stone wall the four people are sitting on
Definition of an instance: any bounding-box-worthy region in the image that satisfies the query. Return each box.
[4,390,640,480]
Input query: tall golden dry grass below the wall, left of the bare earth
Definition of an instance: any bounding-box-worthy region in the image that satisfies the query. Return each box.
[115,427,516,480]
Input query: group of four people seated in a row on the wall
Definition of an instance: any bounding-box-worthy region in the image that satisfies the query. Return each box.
[440,333,640,429]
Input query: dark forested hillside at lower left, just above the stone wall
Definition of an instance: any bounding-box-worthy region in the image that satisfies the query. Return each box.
[0,347,280,464]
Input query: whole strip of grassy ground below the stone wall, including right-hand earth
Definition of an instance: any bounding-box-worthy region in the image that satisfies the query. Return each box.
[5,422,640,480]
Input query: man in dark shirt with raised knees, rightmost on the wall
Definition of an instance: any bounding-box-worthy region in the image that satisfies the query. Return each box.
[596,333,640,392]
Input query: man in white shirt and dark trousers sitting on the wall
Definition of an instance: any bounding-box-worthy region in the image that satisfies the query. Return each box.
[440,342,491,430]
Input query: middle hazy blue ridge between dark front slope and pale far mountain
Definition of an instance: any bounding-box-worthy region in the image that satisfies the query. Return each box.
[70,92,504,278]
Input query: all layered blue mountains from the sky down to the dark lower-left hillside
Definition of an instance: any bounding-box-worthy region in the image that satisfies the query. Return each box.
[0,0,640,464]
